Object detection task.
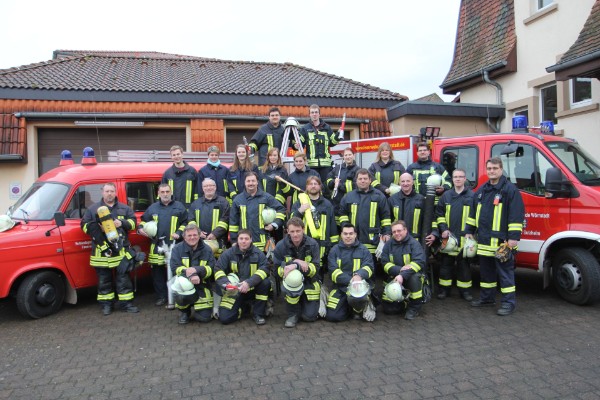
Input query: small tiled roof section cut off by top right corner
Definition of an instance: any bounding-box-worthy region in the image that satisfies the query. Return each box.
[548,0,600,77]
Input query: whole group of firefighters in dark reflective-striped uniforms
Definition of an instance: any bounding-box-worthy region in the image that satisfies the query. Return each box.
[81,104,524,328]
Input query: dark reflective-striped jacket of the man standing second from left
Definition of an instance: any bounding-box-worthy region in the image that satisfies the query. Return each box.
[140,200,188,265]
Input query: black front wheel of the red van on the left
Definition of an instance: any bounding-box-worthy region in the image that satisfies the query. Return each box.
[17,271,65,318]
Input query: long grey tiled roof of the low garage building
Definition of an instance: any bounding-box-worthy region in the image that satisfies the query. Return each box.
[0,50,406,101]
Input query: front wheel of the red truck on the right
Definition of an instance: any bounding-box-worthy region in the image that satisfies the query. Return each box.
[552,247,600,305]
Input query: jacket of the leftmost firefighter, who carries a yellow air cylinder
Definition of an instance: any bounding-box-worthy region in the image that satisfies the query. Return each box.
[81,198,137,268]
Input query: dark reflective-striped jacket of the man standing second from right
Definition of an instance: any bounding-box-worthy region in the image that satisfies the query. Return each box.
[435,187,473,256]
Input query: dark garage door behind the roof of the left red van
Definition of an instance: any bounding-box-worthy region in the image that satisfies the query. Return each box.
[38,128,185,175]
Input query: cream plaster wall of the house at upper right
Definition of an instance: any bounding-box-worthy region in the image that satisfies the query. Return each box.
[461,0,600,149]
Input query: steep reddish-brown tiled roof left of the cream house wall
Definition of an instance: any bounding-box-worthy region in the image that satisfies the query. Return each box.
[440,0,517,89]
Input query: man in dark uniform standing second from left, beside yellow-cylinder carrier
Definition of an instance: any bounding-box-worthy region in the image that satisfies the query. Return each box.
[138,183,188,306]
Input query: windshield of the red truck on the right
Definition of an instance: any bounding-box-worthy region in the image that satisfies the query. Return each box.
[546,142,600,186]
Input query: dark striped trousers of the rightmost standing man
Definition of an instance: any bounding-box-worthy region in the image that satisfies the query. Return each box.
[479,256,517,306]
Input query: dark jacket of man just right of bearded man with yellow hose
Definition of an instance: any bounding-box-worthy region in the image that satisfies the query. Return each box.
[339,187,392,253]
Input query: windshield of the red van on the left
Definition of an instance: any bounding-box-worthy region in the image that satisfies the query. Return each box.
[10,182,69,222]
